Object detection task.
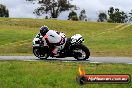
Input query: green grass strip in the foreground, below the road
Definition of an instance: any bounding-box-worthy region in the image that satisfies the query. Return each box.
[0,61,132,88]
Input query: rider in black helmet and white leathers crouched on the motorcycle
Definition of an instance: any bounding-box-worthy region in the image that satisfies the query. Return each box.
[40,26,66,56]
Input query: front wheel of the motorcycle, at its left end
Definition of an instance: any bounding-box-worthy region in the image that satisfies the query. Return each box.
[33,47,49,60]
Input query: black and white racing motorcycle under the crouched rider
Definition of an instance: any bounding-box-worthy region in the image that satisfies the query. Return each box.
[33,33,90,60]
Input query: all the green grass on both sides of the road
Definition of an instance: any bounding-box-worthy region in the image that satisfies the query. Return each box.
[0,18,132,88]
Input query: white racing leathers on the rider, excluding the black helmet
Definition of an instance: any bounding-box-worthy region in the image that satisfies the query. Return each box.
[43,30,66,54]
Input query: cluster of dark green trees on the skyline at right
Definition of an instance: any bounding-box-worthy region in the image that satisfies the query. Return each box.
[97,7,132,23]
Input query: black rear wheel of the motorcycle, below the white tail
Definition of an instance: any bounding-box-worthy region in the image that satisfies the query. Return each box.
[72,44,90,60]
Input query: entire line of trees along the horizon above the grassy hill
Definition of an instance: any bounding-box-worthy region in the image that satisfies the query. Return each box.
[0,0,132,23]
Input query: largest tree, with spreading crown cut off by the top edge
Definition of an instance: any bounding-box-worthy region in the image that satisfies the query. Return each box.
[26,0,76,18]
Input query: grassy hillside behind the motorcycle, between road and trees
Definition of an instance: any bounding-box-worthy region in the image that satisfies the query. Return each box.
[0,18,132,57]
